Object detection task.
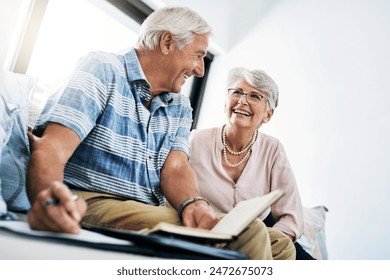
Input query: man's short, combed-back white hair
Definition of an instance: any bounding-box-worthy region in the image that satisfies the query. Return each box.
[136,7,212,50]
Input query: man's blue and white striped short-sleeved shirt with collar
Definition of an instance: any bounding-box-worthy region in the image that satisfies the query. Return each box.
[37,49,192,205]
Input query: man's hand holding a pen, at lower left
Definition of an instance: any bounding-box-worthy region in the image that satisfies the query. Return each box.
[28,181,87,234]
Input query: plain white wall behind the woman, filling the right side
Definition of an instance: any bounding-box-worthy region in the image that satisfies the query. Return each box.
[198,0,390,259]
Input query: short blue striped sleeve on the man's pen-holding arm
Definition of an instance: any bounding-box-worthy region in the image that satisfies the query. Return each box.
[37,52,112,141]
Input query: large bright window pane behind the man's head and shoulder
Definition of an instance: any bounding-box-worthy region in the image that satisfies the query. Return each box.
[27,0,138,103]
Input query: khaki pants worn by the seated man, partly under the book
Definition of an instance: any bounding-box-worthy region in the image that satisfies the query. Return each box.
[77,191,295,260]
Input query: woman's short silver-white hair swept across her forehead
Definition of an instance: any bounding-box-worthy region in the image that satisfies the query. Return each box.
[227,67,279,109]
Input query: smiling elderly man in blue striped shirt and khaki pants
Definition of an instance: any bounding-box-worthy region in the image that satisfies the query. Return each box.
[27,7,295,259]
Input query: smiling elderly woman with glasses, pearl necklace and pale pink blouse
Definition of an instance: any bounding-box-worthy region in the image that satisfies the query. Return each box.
[190,68,312,259]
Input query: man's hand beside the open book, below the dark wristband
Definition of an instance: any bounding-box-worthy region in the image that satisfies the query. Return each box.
[182,200,218,229]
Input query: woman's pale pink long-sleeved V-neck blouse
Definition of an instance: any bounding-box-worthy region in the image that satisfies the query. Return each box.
[190,127,303,239]
